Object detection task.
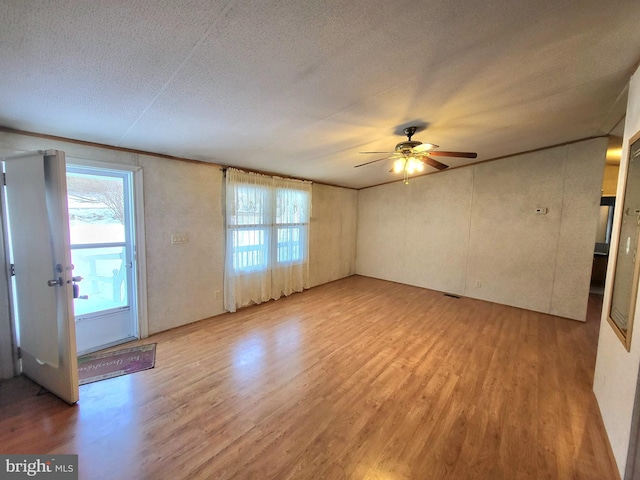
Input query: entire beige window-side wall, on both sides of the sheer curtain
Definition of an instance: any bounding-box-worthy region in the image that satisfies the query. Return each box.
[0,132,358,364]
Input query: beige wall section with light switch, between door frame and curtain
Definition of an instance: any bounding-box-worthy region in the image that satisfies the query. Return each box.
[139,155,224,334]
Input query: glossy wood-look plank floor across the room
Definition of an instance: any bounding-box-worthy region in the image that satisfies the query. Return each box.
[0,276,619,480]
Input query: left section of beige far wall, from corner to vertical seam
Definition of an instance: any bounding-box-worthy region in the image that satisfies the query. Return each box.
[356,168,473,294]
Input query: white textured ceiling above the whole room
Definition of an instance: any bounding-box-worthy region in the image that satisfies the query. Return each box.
[0,0,640,188]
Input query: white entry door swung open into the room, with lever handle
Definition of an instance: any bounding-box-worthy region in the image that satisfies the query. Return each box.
[2,151,79,404]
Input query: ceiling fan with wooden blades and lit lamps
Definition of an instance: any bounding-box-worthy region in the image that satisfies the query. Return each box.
[354,127,478,183]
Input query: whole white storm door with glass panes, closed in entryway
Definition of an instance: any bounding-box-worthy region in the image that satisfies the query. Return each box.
[67,165,140,355]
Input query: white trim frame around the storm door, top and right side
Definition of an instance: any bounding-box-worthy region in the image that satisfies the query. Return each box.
[65,156,149,344]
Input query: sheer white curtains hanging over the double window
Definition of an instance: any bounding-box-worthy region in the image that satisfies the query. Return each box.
[224,168,311,312]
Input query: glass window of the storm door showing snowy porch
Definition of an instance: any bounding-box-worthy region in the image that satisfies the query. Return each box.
[67,167,131,318]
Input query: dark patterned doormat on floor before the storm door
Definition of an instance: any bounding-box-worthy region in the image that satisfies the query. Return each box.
[78,343,156,385]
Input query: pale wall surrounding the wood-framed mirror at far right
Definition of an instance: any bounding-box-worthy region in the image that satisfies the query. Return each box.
[593,63,640,478]
